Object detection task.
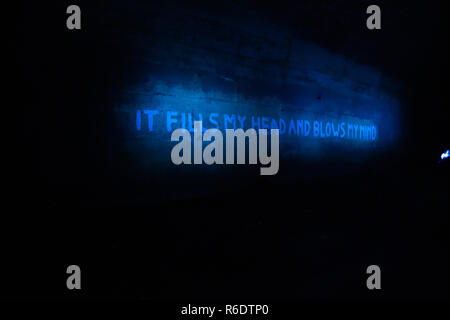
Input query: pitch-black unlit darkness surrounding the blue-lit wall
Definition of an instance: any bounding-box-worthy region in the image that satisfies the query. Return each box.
[15,1,450,301]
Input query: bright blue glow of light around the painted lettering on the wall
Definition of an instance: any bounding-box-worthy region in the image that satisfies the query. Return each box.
[115,34,400,166]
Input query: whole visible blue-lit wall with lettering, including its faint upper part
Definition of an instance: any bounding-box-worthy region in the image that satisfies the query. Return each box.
[96,3,401,188]
